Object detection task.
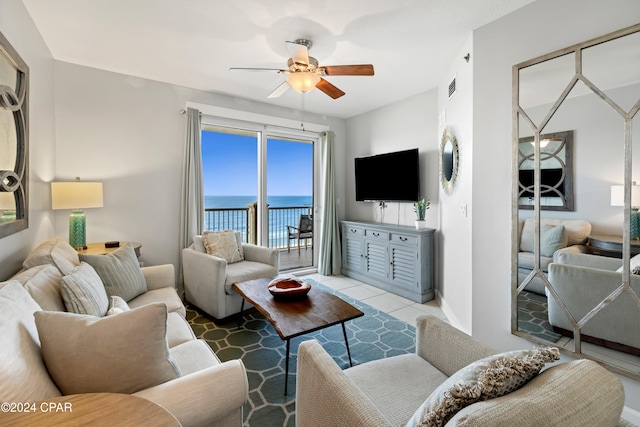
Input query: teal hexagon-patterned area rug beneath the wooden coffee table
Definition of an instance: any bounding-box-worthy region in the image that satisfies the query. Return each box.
[187,279,415,427]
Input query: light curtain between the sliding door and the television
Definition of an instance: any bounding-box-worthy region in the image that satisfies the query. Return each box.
[318,131,342,276]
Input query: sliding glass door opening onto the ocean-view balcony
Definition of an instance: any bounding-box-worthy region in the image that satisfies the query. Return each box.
[202,124,317,271]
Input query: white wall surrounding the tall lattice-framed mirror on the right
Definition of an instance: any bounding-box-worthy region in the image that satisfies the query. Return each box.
[471,0,640,411]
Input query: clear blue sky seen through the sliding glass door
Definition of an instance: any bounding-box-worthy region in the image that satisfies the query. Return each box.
[202,131,313,196]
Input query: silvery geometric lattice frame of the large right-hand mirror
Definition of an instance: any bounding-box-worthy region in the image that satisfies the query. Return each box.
[511,24,640,380]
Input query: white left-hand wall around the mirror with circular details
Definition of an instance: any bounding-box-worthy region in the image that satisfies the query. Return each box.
[0,0,55,280]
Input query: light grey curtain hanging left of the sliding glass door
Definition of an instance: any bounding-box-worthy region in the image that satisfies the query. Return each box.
[178,108,204,295]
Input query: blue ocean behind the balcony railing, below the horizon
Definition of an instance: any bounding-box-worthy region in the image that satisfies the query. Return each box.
[204,196,313,248]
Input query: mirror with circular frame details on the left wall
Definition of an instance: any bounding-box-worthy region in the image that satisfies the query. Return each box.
[0,33,29,238]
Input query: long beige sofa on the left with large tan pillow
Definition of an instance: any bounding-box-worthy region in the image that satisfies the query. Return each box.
[0,239,248,426]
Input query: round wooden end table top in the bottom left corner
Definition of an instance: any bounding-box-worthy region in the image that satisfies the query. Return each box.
[0,393,181,427]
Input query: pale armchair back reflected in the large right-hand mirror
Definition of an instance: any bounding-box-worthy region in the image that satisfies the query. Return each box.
[547,253,640,356]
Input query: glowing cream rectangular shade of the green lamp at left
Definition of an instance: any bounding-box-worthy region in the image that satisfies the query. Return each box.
[51,181,103,209]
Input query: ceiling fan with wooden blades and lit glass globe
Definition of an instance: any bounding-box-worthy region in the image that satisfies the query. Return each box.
[230,39,373,99]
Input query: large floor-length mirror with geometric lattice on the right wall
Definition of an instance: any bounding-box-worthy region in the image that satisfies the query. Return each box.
[511,24,640,379]
